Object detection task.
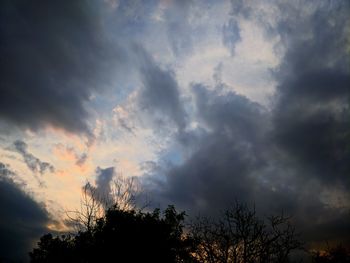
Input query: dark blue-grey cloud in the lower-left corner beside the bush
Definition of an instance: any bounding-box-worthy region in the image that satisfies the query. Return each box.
[0,163,49,262]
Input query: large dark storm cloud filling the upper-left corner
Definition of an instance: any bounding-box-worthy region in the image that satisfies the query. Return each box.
[0,0,116,135]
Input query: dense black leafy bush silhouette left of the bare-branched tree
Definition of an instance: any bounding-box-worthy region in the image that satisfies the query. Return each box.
[30,206,197,263]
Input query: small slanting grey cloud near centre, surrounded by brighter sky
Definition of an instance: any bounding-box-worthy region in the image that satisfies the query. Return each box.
[138,48,186,129]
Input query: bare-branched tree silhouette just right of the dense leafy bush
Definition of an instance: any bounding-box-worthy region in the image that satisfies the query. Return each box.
[190,203,301,263]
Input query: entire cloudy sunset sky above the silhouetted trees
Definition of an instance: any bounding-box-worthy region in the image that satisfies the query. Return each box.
[0,0,350,258]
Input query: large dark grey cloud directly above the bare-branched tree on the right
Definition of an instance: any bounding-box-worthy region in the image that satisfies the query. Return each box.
[144,82,350,248]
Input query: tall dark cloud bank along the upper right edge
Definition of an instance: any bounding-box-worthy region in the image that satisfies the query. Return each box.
[274,1,350,186]
